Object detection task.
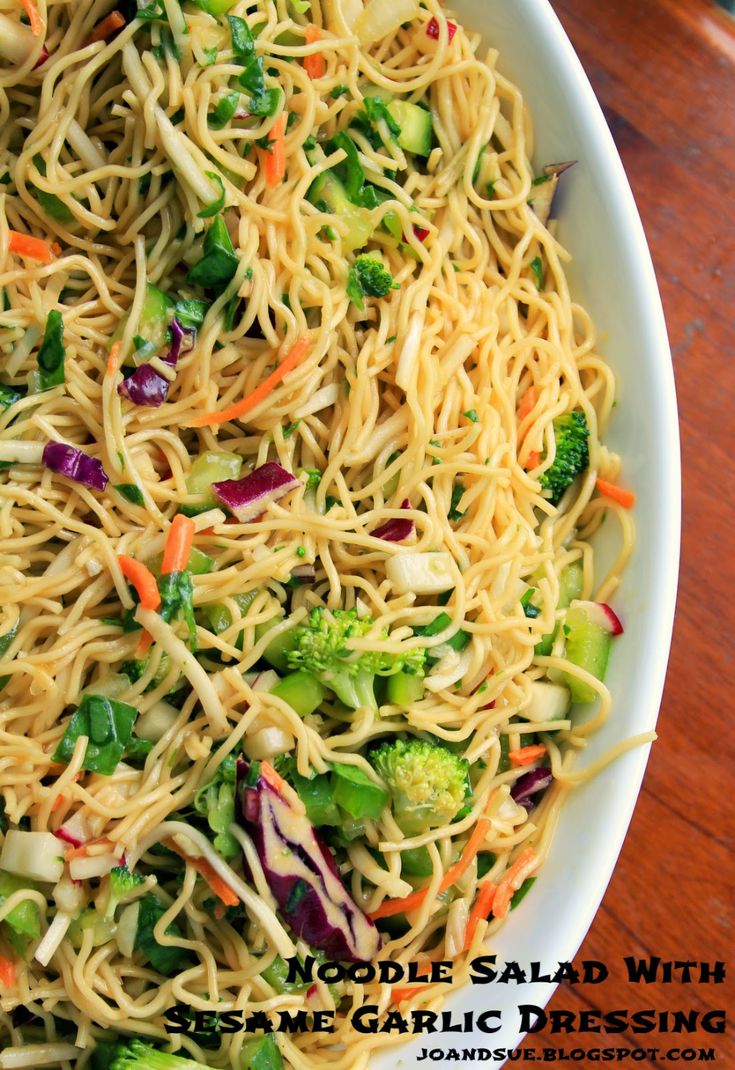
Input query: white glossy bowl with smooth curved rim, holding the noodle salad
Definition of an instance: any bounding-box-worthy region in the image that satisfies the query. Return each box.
[370,0,680,1070]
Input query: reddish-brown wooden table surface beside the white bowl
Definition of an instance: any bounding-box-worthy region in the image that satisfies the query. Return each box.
[521,0,735,1070]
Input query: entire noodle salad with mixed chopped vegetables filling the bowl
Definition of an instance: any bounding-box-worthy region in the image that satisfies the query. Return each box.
[0,0,640,1070]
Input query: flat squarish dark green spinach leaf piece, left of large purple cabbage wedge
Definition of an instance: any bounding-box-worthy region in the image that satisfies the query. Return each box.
[53,694,137,777]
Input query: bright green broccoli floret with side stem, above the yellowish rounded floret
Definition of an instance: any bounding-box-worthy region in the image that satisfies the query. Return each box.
[286,607,426,709]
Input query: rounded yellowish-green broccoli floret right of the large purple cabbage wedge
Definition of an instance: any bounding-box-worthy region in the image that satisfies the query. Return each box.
[368,739,471,836]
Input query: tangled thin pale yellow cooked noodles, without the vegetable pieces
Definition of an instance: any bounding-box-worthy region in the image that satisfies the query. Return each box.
[0,0,634,1070]
